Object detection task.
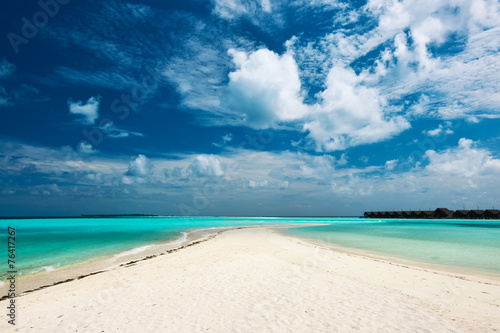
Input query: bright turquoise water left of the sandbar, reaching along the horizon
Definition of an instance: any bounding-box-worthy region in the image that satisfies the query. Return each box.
[0,217,324,280]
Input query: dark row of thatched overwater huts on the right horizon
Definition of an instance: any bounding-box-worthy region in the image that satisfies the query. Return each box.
[363,208,500,219]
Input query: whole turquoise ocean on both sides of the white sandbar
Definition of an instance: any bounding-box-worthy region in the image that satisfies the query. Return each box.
[0,217,500,280]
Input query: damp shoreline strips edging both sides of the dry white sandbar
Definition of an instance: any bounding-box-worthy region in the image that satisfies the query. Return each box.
[0,223,500,301]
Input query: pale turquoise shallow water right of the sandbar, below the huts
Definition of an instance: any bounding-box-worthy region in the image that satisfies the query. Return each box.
[287,219,500,273]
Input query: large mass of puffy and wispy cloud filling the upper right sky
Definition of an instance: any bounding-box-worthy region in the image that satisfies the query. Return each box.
[159,0,500,152]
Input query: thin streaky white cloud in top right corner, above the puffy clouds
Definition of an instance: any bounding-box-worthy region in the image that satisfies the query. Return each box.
[289,0,500,126]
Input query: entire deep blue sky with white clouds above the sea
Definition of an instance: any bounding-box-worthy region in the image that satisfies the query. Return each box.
[0,0,500,216]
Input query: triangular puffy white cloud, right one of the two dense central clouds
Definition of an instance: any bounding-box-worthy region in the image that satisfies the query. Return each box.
[304,67,410,151]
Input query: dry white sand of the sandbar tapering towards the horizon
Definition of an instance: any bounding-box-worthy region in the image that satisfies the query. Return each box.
[0,227,500,333]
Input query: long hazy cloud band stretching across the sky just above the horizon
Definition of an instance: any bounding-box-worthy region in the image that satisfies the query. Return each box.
[0,139,500,215]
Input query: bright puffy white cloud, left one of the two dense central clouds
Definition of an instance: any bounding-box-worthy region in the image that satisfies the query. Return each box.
[222,49,307,129]
